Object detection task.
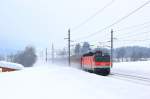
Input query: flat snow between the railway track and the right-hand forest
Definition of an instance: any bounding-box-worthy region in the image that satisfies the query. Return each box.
[112,61,150,78]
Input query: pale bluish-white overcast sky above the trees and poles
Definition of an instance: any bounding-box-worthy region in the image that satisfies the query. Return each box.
[0,0,150,52]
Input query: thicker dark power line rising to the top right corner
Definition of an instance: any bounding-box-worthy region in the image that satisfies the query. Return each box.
[73,0,150,40]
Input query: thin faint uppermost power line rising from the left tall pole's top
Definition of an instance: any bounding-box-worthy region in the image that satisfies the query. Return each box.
[71,0,115,31]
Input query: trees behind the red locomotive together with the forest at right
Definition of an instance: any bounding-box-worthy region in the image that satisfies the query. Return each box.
[74,42,150,62]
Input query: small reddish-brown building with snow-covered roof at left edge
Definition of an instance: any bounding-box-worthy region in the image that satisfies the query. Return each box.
[0,61,24,72]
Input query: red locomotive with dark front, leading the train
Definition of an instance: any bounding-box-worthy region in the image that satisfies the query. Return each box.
[80,51,112,76]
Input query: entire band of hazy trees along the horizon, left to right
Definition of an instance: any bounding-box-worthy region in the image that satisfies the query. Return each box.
[0,42,150,63]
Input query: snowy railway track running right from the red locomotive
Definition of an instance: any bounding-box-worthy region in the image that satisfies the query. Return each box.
[110,73,150,86]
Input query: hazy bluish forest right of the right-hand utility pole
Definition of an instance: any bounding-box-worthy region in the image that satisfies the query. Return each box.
[114,46,150,61]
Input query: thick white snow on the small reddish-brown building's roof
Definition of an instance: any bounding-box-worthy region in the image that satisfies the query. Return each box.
[0,61,24,69]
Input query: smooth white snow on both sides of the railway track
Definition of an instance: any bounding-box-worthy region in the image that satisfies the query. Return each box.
[0,62,150,99]
